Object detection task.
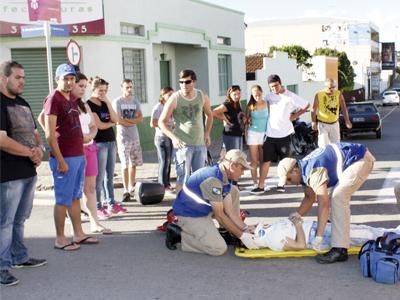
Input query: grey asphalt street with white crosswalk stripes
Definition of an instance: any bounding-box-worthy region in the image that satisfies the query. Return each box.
[0,106,400,300]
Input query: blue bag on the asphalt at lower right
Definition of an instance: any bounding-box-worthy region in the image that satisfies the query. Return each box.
[358,232,400,284]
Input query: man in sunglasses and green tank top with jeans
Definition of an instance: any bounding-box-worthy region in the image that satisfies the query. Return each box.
[158,70,212,192]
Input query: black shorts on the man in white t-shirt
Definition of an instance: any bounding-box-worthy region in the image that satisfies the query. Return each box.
[263,135,291,162]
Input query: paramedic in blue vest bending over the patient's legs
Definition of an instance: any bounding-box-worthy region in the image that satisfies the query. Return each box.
[277,143,375,264]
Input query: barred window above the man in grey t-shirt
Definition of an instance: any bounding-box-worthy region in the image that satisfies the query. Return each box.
[122,48,147,103]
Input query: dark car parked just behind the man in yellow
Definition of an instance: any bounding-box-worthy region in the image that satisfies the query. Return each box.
[340,101,382,139]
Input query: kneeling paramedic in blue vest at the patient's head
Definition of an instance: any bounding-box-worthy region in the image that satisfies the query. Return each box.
[173,149,258,256]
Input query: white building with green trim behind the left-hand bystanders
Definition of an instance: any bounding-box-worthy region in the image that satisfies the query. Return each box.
[0,0,246,148]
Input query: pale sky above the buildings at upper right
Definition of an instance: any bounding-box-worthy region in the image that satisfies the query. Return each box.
[206,0,400,50]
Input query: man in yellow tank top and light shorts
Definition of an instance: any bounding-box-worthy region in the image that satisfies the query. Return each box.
[311,78,353,147]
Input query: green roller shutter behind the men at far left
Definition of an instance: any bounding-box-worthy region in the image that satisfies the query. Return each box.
[11,48,68,142]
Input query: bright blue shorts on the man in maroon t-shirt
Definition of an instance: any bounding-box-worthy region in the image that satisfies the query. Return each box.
[49,155,85,206]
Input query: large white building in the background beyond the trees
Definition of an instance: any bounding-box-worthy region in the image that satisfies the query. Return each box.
[245,18,381,97]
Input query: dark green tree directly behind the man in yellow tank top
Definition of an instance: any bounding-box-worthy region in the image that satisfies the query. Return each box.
[314,48,356,91]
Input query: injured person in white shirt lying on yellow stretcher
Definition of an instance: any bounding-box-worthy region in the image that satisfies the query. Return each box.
[254,215,400,251]
